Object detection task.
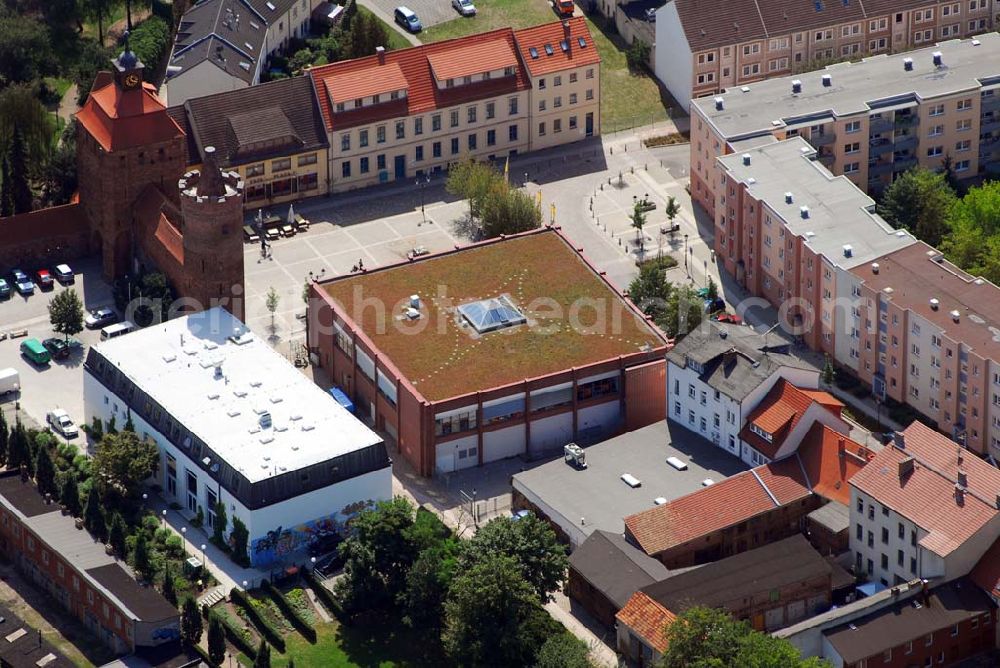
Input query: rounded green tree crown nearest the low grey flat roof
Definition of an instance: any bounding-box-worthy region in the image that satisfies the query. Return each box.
[461,513,569,603]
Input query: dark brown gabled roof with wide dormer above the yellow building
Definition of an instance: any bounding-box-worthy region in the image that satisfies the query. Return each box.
[170,76,327,167]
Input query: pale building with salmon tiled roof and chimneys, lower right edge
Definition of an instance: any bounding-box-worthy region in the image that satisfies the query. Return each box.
[850,422,1000,586]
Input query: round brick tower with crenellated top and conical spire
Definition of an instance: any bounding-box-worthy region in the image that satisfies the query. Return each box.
[177,146,245,320]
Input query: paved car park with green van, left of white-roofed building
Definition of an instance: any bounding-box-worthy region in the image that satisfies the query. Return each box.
[0,257,113,442]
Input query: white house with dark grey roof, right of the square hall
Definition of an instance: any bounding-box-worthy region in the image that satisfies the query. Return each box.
[667,322,819,466]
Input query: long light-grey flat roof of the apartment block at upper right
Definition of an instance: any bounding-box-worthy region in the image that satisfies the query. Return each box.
[691,33,1000,139]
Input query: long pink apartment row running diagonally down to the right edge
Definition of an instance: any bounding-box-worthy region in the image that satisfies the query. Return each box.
[715,137,1000,457]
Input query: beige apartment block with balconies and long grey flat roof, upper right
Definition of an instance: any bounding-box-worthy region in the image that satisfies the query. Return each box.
[691,34,1000,214]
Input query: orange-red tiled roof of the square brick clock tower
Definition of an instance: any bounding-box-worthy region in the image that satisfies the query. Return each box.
[76,74,184,151]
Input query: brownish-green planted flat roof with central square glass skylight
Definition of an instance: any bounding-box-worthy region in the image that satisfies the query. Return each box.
[320,228,666,402]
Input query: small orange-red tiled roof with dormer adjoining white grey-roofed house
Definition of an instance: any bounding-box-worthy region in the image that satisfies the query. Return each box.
[740,378,844,458]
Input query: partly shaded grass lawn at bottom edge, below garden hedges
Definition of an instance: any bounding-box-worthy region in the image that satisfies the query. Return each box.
[239,620,447,668]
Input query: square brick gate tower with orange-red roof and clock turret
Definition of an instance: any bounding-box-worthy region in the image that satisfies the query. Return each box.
[76,39,187,280]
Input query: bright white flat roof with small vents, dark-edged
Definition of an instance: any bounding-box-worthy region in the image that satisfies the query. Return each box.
[88,308,382,483]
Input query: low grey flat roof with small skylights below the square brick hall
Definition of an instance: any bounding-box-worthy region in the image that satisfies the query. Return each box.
[513,421,747,535]
